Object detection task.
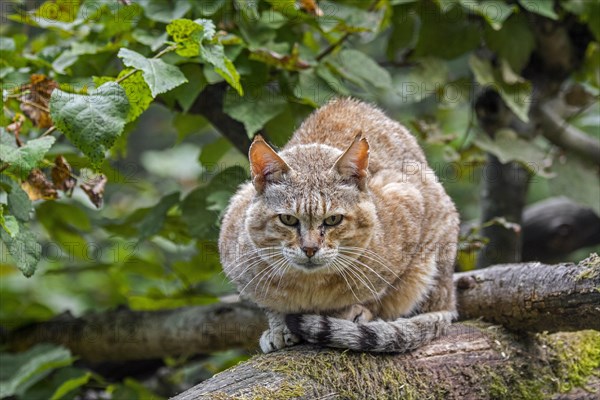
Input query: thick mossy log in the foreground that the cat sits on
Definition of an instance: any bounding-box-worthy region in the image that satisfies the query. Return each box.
[173,324,600,400]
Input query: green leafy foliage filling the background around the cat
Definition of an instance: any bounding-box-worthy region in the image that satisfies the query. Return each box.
[0,0,600,399]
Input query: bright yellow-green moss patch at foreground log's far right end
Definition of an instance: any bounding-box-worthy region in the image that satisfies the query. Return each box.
[545,330,600,392]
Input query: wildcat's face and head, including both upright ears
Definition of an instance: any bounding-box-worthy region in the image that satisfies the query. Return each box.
[246,135,377,272]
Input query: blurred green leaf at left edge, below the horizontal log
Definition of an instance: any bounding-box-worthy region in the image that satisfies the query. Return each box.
[0,344,74,398]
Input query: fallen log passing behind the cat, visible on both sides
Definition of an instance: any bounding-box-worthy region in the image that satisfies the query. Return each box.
[3,256,600,362]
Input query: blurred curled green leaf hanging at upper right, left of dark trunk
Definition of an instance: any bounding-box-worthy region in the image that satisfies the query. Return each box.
[469,55,532,122]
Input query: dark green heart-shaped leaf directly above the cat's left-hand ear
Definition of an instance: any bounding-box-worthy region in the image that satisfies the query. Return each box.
[223,88,286,138]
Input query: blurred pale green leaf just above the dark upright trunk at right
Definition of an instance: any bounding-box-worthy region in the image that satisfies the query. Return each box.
[475,129,547,172]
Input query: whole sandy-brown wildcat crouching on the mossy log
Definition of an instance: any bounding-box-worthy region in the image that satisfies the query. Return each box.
[219,98,459,352]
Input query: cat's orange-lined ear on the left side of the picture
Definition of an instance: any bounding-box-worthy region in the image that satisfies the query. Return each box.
[248,135,290,193]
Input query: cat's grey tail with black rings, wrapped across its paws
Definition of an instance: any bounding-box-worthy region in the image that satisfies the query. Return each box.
[285,311,456,353]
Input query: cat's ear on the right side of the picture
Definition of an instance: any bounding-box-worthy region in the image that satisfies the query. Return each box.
[333,134,369,190]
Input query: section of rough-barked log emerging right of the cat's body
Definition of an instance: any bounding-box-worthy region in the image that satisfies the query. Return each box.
[454,255,600,332]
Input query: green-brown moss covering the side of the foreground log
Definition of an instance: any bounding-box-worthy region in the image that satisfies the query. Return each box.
[237,322,600,400]
